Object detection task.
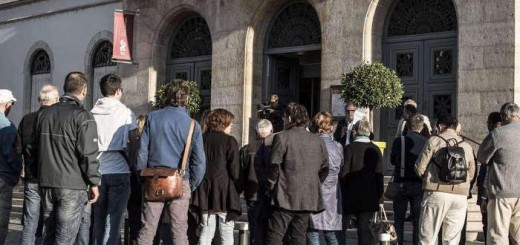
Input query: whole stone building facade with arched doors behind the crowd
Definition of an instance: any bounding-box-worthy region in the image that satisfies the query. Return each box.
[0,0,520,167]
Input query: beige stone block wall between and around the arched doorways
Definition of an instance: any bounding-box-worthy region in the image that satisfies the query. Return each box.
[120,0,518,144]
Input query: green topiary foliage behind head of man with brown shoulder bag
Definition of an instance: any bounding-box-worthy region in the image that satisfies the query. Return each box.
[153,79,202,118]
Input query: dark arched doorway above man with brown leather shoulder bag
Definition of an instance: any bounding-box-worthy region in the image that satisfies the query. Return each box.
[166,15,212,112]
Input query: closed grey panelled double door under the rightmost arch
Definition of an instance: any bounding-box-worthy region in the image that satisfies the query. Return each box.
[381,38,457,174]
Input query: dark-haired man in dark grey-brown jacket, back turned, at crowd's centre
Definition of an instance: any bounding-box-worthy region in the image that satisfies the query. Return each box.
[267,103,329,245]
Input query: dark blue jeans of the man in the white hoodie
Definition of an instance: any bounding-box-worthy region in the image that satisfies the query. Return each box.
[92,174,130,245]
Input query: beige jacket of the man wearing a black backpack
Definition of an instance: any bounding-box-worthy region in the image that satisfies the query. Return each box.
[415,129,475,196]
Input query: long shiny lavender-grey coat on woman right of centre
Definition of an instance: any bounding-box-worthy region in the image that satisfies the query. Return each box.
[309,134,343,231]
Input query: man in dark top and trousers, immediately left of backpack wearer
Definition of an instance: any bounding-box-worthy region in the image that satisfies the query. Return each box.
[390,114,428,245]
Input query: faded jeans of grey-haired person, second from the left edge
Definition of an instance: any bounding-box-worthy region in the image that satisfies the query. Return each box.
[20,181,41,245]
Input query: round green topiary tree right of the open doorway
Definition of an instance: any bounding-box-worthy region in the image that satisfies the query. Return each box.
[341,62,404,152]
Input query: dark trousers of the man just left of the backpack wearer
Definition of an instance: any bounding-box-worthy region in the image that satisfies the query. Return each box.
[393,182,423,245]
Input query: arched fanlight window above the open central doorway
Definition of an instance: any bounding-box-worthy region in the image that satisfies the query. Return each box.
[267,3,321,49]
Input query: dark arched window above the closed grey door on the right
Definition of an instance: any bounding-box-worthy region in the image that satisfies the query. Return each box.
[387,0,457,37]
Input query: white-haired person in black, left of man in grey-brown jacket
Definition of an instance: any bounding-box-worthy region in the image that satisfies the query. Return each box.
[240,119,273,245]
